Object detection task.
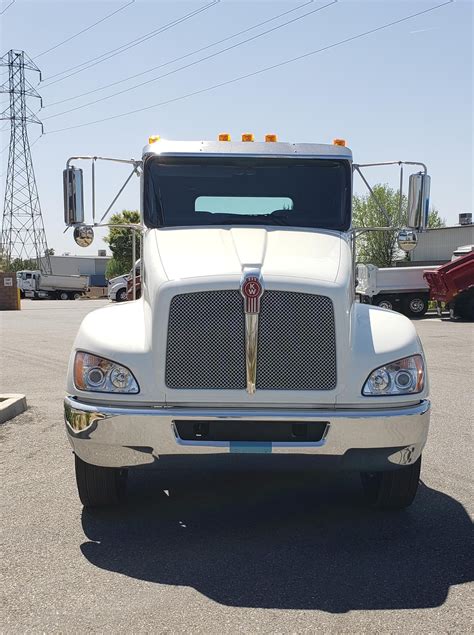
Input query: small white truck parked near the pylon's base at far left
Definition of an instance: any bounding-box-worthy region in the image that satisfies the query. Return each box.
[16,269,89,300]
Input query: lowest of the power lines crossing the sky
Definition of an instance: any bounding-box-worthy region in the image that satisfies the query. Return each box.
[45,0,454,134]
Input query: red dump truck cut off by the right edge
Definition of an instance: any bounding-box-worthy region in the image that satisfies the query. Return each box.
[423,251,474,320]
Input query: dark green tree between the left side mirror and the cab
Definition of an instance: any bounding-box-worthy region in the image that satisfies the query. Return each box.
[104,209,140,280]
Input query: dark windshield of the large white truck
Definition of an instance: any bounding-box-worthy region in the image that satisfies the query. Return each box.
[144,157,351,231]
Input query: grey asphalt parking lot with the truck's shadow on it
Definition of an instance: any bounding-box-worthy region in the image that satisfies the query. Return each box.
[0,300,474,633]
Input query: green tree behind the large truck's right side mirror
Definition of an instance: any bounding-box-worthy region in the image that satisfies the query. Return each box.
[352,183,445,267]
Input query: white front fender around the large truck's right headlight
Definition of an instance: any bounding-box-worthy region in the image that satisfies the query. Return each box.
[337,303,429,407]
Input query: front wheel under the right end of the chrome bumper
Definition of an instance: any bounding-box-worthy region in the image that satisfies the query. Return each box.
[361,456,421,509]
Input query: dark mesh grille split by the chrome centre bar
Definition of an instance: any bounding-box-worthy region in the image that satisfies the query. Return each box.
[165,290,336,390]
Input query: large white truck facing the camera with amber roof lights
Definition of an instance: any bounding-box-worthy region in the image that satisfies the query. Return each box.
[63,134,430,509]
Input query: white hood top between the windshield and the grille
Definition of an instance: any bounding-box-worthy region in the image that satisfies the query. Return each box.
[155,227,349,283]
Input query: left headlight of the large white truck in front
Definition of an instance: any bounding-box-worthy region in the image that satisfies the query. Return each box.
[74,351,139,393]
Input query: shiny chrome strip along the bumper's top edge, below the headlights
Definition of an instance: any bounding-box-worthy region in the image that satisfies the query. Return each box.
[64,396,430,421]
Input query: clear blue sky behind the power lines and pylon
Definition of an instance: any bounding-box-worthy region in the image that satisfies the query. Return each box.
[0,0,473,254]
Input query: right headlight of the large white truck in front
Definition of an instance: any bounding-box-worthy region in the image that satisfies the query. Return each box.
[362,355,425,397]
